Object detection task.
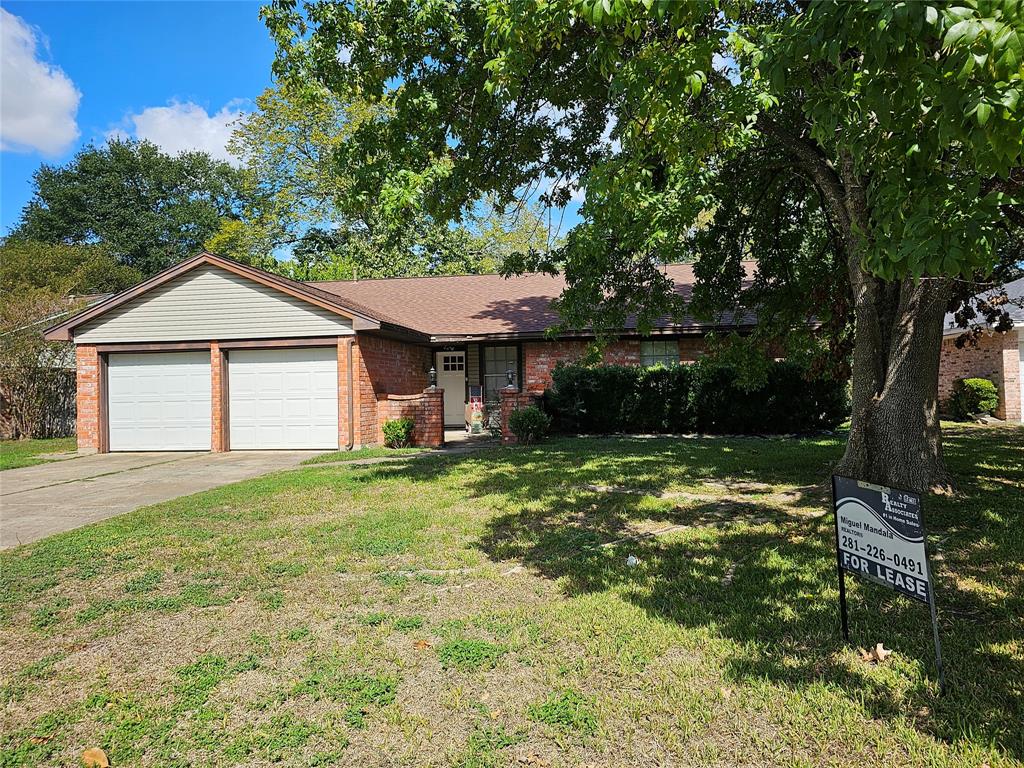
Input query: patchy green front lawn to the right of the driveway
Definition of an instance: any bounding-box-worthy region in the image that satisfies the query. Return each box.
[0,427,1024,768]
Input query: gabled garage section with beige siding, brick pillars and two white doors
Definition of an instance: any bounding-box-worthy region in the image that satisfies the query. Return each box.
[46,253,380,452]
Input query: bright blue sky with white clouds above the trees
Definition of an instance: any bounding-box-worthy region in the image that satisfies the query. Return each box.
[0,0,579,243]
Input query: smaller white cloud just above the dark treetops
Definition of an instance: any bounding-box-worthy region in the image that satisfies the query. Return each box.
[106,101,245,164]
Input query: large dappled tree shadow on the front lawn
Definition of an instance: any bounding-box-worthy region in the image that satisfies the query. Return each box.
[368,429,1024,759]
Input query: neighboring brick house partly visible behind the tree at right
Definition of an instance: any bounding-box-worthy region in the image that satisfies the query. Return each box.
[939,278,1024,421]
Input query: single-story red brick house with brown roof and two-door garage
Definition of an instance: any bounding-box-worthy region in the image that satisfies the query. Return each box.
[46,253,755,452]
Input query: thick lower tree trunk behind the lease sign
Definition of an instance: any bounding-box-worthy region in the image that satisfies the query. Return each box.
[836,257,953,493]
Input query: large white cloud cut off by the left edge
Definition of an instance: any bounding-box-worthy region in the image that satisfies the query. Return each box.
[0,8,82,157]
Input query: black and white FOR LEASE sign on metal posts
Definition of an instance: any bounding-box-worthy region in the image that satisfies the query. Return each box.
[833,475,946,694]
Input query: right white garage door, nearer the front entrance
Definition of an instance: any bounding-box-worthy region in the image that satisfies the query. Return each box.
[227,347,338,451]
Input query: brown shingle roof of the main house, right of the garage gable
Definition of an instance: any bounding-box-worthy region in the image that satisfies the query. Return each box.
[306,264,756,338]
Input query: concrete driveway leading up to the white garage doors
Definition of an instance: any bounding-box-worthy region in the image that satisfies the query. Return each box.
[0,451,324,549]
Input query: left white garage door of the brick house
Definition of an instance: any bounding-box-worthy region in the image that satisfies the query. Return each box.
[106,351,210,451]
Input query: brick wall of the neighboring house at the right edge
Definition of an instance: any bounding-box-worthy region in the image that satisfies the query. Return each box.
[939,331,1021,421]
